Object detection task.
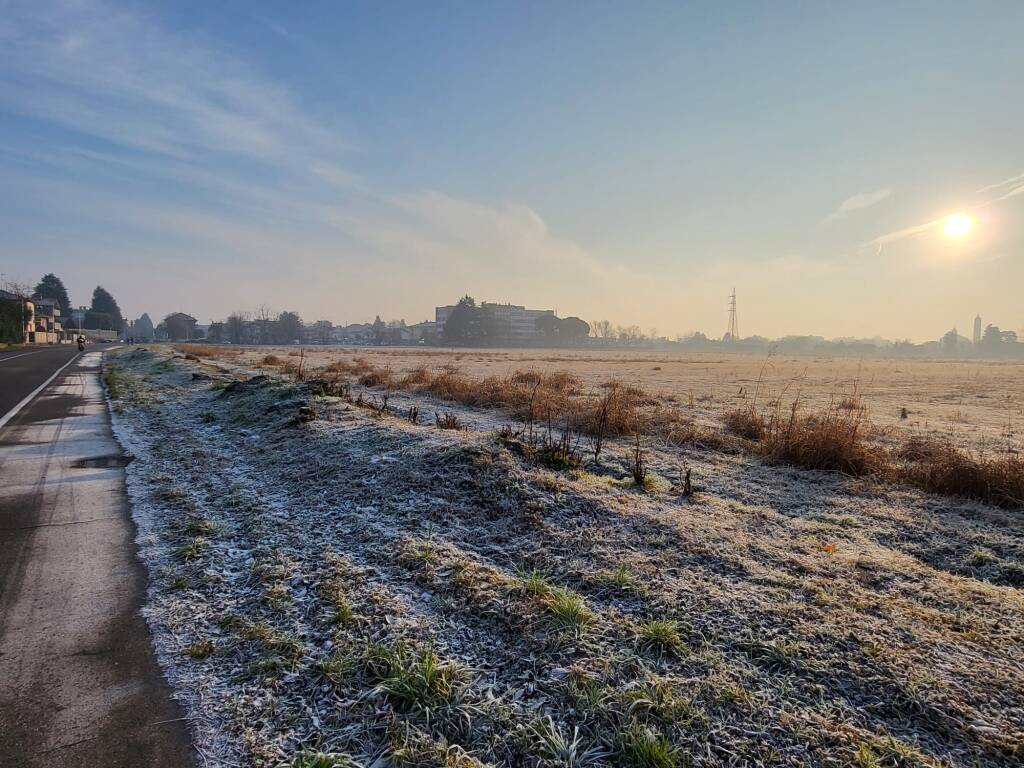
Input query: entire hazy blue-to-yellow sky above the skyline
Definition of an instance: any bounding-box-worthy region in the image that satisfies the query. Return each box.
[0,0,1024,341]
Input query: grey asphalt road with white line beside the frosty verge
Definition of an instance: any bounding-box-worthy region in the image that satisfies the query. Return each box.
[0,346,194,768]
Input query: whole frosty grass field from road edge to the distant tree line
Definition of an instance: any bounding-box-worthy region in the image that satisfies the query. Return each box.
[105,347,1024,768]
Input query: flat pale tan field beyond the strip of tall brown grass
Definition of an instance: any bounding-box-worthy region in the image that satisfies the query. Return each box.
[207,347,1024,452]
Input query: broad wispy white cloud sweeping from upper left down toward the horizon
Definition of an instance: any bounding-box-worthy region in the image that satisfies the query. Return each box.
[0,0,654,325]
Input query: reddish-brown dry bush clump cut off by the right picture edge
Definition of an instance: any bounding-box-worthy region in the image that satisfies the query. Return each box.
[895,437,1024,509]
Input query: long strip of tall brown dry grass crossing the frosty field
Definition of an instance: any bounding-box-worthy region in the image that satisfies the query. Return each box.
[176,344,1024,507]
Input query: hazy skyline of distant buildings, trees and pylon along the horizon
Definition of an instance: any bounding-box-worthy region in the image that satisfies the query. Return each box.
[0,273,1024,358]
